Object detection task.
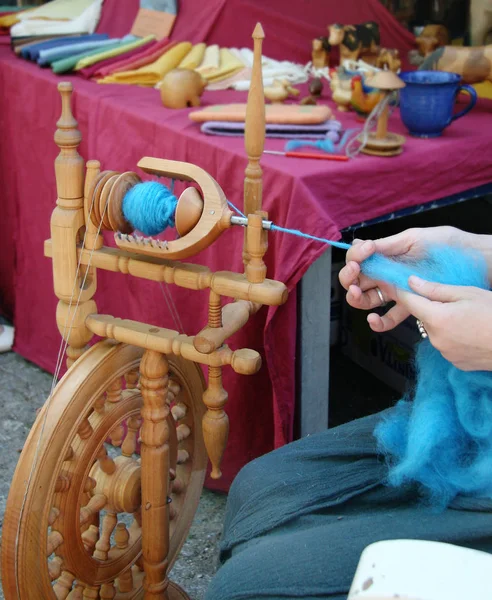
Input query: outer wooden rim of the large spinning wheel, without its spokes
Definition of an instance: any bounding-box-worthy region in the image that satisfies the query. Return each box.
[2,340,206,600]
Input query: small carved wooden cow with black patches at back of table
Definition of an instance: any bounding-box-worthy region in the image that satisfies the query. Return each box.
[328,21,380,64]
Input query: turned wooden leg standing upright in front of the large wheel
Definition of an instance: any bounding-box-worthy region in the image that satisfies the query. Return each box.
[140,350,170,600]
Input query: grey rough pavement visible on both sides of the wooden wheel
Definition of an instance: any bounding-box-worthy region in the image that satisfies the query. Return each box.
[0,352,225,600]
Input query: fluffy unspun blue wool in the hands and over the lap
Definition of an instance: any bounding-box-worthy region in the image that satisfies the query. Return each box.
[362,247,492,509]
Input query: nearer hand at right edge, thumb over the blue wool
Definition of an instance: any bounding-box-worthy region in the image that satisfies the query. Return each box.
[397,276,492,371]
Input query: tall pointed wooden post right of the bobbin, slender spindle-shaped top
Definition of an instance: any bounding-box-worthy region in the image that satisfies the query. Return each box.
[243,23,265,265]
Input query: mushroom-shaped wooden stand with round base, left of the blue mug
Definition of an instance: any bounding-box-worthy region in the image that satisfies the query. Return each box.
[359,71,405,156]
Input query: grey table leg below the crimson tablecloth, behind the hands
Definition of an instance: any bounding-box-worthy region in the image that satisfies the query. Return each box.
[297,248,331,437]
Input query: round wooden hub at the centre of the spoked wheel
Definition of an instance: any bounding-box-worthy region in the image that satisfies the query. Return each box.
[90,456,142,513]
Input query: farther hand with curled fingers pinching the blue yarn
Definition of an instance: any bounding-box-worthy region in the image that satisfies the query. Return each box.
[339,227,473,332]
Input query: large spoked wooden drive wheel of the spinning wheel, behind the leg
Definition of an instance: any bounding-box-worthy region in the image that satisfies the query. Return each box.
[2,342,206,600]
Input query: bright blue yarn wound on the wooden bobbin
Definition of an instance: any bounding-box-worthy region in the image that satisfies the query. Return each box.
[122,181,178,235]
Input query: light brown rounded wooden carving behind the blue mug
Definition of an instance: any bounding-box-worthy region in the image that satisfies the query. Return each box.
[419,45,492,84]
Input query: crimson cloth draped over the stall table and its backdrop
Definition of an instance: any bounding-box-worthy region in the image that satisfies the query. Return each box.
[0,0,492,488]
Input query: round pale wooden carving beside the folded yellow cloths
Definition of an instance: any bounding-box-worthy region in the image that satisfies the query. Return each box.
[159,69,207,108]
